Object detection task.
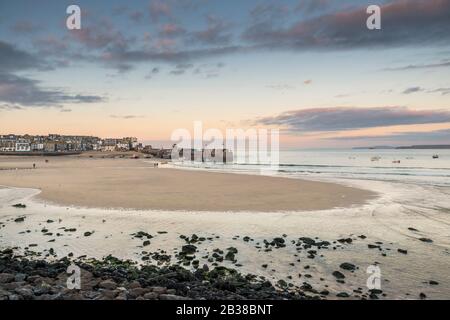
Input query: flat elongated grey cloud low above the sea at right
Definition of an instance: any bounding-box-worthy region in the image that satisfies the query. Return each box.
[254,107,450,132]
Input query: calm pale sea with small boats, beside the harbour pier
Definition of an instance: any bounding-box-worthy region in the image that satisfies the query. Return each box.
[175,149,450,186]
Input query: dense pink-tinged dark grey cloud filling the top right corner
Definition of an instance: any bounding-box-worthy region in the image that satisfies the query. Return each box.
[244,0,450,49]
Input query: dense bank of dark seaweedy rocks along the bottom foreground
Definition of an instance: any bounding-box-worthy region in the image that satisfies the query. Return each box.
[0,249,319,300]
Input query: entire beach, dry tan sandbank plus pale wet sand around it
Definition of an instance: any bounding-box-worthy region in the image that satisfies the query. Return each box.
[0,156,450,299]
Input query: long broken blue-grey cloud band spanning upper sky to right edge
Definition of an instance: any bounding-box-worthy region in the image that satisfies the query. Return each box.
[61,0,450,70]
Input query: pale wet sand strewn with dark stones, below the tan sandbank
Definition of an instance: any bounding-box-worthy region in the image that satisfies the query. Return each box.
[0,182,450,299]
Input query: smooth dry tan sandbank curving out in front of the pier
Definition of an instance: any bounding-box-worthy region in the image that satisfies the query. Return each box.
[0,154,375,212]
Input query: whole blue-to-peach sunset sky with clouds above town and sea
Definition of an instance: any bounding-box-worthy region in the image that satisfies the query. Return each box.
[0,0,450,148]
